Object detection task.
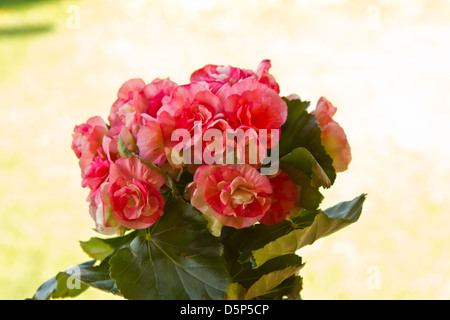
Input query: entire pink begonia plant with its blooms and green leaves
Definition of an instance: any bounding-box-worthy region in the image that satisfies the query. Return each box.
[33,60,365,300]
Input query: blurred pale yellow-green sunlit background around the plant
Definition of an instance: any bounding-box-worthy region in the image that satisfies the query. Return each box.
[0,0,450,299]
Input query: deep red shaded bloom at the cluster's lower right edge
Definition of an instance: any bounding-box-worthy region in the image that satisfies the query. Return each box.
[259,170,301,225]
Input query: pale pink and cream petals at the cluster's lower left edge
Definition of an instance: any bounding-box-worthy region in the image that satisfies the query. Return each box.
[87,182,125,235]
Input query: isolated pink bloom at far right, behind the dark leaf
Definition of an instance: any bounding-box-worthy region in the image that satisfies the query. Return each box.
[313,97,352,172]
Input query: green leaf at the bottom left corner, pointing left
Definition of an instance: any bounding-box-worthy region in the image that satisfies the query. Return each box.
[33,260,119,300]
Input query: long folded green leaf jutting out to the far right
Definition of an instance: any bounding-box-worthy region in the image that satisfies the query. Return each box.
[252,194,366,267]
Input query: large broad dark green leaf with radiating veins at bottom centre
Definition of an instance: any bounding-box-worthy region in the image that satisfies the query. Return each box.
[110,199,231,300]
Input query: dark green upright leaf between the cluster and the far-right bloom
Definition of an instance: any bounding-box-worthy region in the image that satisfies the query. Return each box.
[279,98,336,185]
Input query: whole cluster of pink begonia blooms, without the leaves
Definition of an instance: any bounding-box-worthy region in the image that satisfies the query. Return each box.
[72,60,351,234]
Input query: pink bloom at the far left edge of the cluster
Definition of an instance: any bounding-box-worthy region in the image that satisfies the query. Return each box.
[72,116,108,177]
